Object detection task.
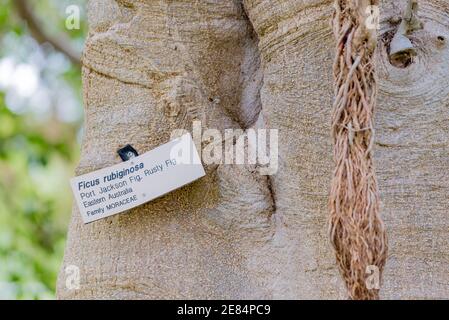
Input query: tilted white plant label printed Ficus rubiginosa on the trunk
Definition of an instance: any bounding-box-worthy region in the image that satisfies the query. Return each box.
[70,134,205,223]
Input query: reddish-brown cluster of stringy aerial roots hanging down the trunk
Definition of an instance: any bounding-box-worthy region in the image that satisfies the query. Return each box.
[329,0,387,299]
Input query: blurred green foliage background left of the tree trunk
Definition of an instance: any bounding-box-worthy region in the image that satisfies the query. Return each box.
[0,0,86,299]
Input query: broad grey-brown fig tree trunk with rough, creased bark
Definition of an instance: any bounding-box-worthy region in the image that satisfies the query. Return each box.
[58,0,449,299]
